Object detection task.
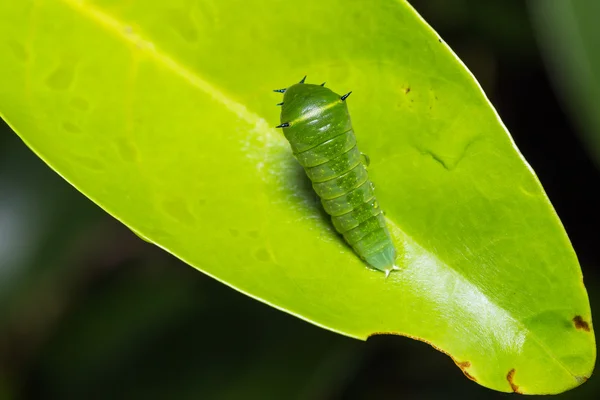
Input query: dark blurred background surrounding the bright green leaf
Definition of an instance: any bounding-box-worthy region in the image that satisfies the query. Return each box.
[0,0,600,400]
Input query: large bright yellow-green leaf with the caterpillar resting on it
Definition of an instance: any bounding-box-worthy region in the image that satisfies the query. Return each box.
[0,0,595,393]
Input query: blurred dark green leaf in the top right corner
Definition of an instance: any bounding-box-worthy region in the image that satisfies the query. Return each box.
[529,0,600,166]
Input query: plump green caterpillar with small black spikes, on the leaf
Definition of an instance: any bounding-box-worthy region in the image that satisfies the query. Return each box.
[275,77,398,277]
